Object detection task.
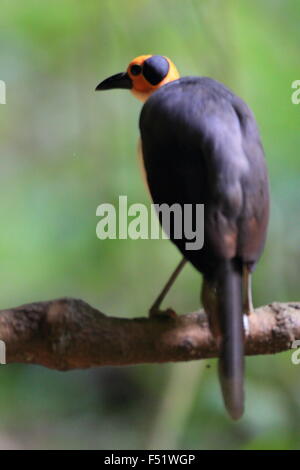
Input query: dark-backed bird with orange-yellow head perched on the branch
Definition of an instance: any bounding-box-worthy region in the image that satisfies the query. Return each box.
[96,54,270,420]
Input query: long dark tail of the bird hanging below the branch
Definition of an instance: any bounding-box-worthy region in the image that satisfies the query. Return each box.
[217,261,244,419]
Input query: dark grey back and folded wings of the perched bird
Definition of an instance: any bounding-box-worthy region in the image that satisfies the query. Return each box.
[140,77,268,277]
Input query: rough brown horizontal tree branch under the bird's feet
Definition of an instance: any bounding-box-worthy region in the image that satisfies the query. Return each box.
[0,298,300,370]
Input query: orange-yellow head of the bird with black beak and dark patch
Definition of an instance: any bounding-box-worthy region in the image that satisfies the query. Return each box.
[96,55,179,101]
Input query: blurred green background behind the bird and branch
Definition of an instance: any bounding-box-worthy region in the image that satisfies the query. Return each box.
[0,0,300,449]
